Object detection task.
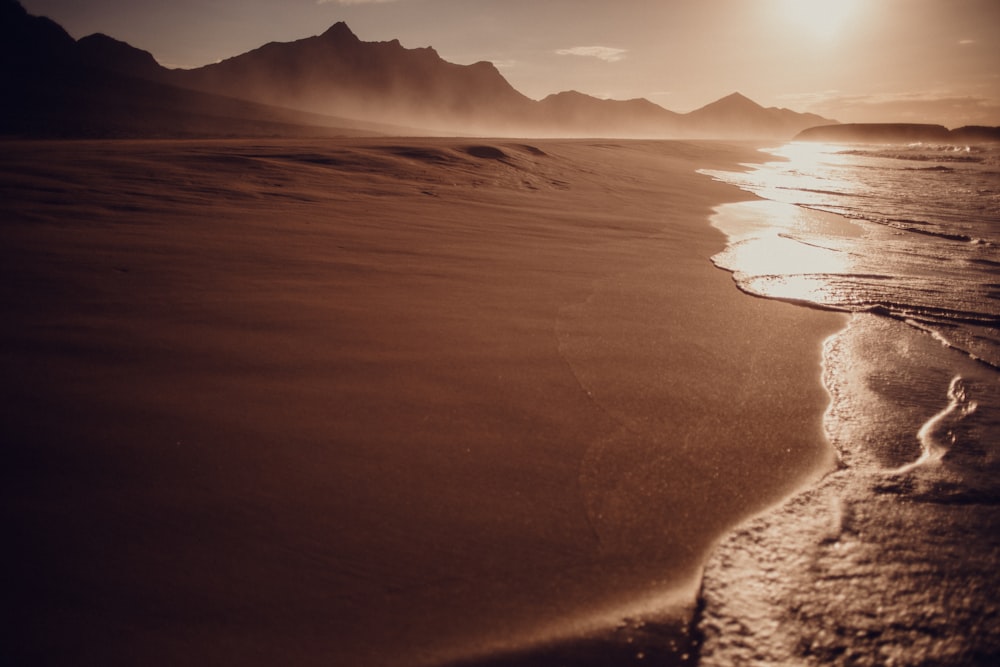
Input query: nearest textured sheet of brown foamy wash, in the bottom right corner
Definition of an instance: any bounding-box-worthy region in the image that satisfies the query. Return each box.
[700,314,1000,667]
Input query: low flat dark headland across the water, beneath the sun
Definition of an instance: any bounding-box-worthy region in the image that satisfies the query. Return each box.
[795,123,1000,144]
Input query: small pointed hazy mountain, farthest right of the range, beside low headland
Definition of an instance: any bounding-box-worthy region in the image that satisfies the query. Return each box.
[682,93,830,139]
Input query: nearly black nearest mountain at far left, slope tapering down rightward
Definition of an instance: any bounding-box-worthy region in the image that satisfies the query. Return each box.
[0,0,418,137]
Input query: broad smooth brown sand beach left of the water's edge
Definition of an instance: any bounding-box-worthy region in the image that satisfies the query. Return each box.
[0,139,844,666]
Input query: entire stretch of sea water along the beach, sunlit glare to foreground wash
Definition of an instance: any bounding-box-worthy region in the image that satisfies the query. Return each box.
[702,143,1000,665]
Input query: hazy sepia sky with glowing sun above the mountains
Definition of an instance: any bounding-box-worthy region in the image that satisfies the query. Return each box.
[22,0,1000,126]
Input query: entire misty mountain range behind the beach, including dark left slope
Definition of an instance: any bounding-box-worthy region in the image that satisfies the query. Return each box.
[0,0,835,139]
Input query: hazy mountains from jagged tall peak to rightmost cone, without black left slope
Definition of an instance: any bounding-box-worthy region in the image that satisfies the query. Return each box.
[171,28,829,138]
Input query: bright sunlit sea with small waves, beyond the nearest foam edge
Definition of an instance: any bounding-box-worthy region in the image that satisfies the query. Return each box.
[707,144,1000,367]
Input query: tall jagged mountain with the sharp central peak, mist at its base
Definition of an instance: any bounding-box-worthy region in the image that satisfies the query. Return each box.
[170,23,533,132]
